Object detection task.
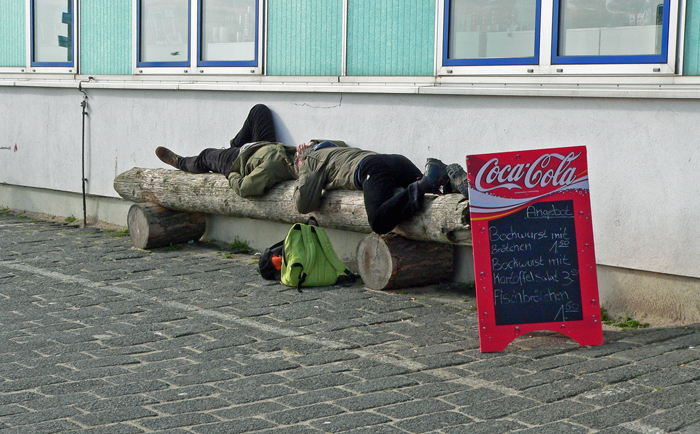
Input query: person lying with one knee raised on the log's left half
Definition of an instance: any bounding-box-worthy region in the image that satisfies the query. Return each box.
[156,104,308,197]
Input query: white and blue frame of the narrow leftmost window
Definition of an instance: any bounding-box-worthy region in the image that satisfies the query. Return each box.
[25,0,80,74]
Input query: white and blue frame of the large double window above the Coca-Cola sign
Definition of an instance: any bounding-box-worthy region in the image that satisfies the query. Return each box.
[435,0,685,77]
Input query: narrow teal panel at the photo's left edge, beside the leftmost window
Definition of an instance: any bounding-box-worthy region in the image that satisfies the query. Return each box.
[0,0,27,67]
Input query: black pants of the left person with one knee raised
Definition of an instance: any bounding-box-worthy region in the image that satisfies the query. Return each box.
[177,104,277,178]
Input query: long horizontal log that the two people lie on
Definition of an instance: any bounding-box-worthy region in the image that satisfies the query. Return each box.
[114,168,471,245]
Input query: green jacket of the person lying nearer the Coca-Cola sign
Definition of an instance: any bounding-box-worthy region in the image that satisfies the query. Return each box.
[294,148,377,214]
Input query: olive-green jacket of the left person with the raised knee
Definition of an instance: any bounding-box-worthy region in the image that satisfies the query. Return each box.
[228,142,296,197]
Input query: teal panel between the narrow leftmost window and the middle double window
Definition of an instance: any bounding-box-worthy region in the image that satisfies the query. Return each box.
[78,0,132,75]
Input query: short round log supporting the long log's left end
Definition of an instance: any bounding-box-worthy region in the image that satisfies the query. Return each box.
[127,203,206,249]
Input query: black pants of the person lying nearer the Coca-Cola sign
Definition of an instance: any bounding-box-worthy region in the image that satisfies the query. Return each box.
[359,154,423,234]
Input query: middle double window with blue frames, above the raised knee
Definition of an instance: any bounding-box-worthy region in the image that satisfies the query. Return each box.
[136,0,262,73]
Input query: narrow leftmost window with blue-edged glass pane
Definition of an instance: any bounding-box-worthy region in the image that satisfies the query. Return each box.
[29,0,76,67]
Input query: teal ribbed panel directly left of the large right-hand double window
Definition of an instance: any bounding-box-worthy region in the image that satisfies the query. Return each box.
[347,0,435,76]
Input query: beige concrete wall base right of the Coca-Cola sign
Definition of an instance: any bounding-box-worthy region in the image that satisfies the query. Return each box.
[597,265,700,325]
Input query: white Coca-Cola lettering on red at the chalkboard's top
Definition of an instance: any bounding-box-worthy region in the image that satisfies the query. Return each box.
[474,152,581,192]
